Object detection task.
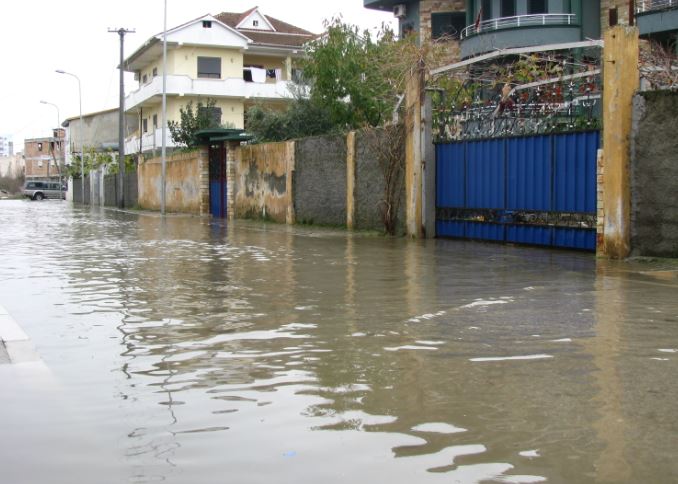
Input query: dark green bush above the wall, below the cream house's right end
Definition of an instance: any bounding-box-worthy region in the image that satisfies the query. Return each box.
[245,99,335,143]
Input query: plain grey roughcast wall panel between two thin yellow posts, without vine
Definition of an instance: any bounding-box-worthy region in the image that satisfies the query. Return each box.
[293,136,346,225]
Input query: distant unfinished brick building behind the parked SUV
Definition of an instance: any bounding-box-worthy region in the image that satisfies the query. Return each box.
[24,128,65,180]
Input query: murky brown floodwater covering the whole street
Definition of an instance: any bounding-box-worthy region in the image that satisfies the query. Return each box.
[0,201,678,484]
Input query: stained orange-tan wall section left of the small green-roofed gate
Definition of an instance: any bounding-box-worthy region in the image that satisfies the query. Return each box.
[138,149,208,214]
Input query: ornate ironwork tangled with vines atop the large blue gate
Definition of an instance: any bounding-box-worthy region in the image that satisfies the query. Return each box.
[429,50,602,142]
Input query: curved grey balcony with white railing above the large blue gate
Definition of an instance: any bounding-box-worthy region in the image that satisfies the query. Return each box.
[461,13,584,59]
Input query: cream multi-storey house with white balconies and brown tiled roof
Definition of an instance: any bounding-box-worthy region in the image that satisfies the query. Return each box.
[125,8,315,153]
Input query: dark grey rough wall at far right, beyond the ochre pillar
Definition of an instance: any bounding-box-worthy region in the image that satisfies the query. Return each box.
[631,91,678,257]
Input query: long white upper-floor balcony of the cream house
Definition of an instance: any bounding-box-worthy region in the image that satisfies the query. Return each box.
[125,75,293,111]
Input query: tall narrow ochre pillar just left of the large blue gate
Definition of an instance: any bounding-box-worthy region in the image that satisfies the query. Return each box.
[405,65,424,238]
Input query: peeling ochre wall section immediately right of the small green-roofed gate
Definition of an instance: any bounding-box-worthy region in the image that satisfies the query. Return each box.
[234,141,294,223]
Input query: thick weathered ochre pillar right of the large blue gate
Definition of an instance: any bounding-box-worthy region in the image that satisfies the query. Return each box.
[598,25,640,259]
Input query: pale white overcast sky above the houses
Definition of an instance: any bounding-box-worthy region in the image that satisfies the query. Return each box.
[0,0,393,151]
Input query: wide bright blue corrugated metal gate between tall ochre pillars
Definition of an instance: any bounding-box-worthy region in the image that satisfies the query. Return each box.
[436,131,600,250]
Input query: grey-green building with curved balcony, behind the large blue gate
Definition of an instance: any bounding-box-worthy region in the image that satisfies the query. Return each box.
[364,0,678,59]
